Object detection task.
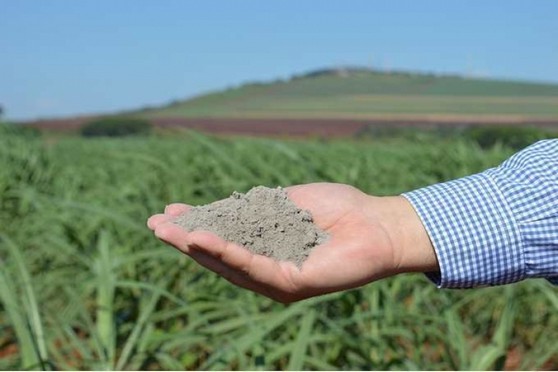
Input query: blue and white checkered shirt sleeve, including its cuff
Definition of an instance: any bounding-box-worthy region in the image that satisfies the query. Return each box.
[403,139,558,288]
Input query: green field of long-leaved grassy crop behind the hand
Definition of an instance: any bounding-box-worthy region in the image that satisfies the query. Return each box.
[0,129,558,370]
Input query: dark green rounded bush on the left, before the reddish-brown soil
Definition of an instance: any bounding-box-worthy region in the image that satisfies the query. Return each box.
[81,116,152,137]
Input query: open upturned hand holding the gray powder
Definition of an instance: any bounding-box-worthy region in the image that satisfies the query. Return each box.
[148,183,437,303]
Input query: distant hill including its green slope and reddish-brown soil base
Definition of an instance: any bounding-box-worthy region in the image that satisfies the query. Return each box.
[27,68,558,137]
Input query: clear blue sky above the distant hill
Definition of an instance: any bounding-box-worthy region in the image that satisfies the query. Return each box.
[0,0,558,120]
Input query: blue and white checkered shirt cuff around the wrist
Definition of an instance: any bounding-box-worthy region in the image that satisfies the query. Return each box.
[402,172,526,288]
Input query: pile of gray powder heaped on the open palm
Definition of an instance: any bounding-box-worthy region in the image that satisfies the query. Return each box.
[174,186,328,268]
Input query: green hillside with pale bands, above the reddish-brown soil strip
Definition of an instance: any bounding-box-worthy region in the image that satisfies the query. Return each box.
[141,69,558,119]
